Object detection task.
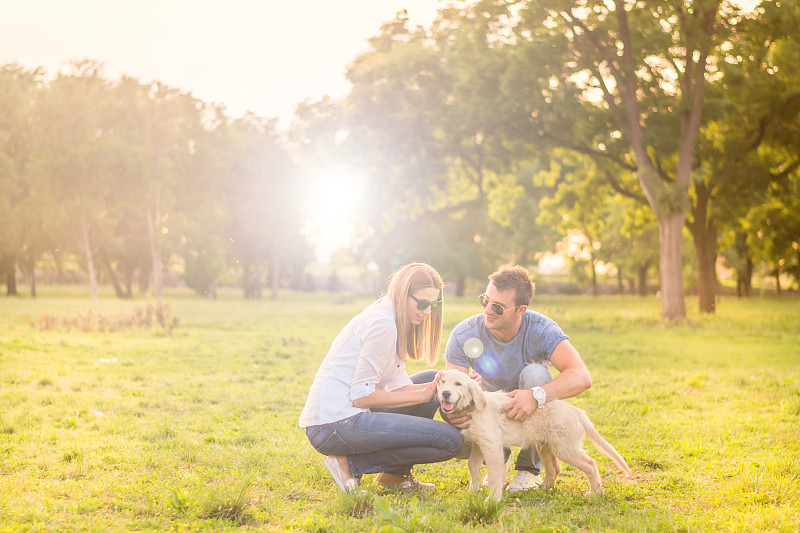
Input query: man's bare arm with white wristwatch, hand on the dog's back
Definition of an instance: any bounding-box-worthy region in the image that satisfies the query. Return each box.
[503,340,592,422]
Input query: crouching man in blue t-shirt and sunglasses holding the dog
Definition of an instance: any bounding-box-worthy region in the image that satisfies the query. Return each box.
[441,266,592,492]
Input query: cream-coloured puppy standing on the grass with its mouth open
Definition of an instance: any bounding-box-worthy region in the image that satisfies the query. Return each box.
[437,370,631,500]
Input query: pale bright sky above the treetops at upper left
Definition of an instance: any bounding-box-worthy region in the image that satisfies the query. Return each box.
[0,0,441,125]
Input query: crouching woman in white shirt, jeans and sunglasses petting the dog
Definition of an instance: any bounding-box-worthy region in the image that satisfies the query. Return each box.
[300,263,463,492]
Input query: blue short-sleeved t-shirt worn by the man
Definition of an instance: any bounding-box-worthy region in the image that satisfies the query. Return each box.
[445,311,569,391]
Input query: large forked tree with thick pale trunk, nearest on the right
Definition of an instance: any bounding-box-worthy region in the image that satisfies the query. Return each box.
[509,0,727,319]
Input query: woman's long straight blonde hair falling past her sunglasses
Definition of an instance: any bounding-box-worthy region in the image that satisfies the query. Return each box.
[387,263,444,365]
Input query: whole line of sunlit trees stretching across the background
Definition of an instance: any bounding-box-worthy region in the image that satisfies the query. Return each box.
[0,0,800,318]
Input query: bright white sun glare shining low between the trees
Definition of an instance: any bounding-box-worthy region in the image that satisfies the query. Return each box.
[304,168,359,263]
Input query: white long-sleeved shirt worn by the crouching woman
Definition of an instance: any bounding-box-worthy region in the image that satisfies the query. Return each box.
[300,296,411,428]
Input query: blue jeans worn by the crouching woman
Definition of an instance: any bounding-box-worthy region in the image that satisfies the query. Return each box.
[306,370,464,477]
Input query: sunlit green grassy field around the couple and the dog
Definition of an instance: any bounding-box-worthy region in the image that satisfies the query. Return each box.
[0,287,800,532]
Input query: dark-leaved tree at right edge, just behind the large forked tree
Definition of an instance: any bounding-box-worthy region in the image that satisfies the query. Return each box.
[686,3,800,313]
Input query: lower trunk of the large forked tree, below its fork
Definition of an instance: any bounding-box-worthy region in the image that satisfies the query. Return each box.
[658,212,686,320]
